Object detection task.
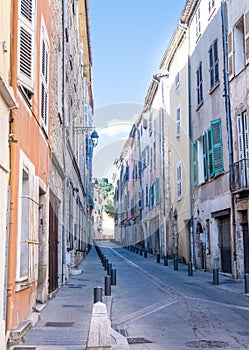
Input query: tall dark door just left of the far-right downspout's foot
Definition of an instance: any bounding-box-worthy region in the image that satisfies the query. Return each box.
[219,216,232,273]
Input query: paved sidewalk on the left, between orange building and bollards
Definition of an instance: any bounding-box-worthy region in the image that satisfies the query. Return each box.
[10,247,110,350]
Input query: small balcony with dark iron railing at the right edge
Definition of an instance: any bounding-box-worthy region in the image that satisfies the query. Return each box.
[232,159,249,193]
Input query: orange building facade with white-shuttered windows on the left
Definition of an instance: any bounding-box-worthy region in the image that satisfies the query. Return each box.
[6,0,51,334]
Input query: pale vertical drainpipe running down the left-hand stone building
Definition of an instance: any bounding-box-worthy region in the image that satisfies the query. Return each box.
[62,0,67,283]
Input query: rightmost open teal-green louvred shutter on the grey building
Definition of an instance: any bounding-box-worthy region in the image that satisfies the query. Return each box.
[211,119,223,174]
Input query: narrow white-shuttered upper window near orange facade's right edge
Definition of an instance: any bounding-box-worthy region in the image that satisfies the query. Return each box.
[40,23,49,130]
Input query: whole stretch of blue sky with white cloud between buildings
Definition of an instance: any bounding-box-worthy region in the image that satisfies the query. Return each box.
[88,0,186,178]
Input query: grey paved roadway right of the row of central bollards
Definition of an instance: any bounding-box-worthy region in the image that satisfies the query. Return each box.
[99,242,249,350]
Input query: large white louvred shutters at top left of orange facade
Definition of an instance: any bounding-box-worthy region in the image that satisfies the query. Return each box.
[18,0,35,98]
